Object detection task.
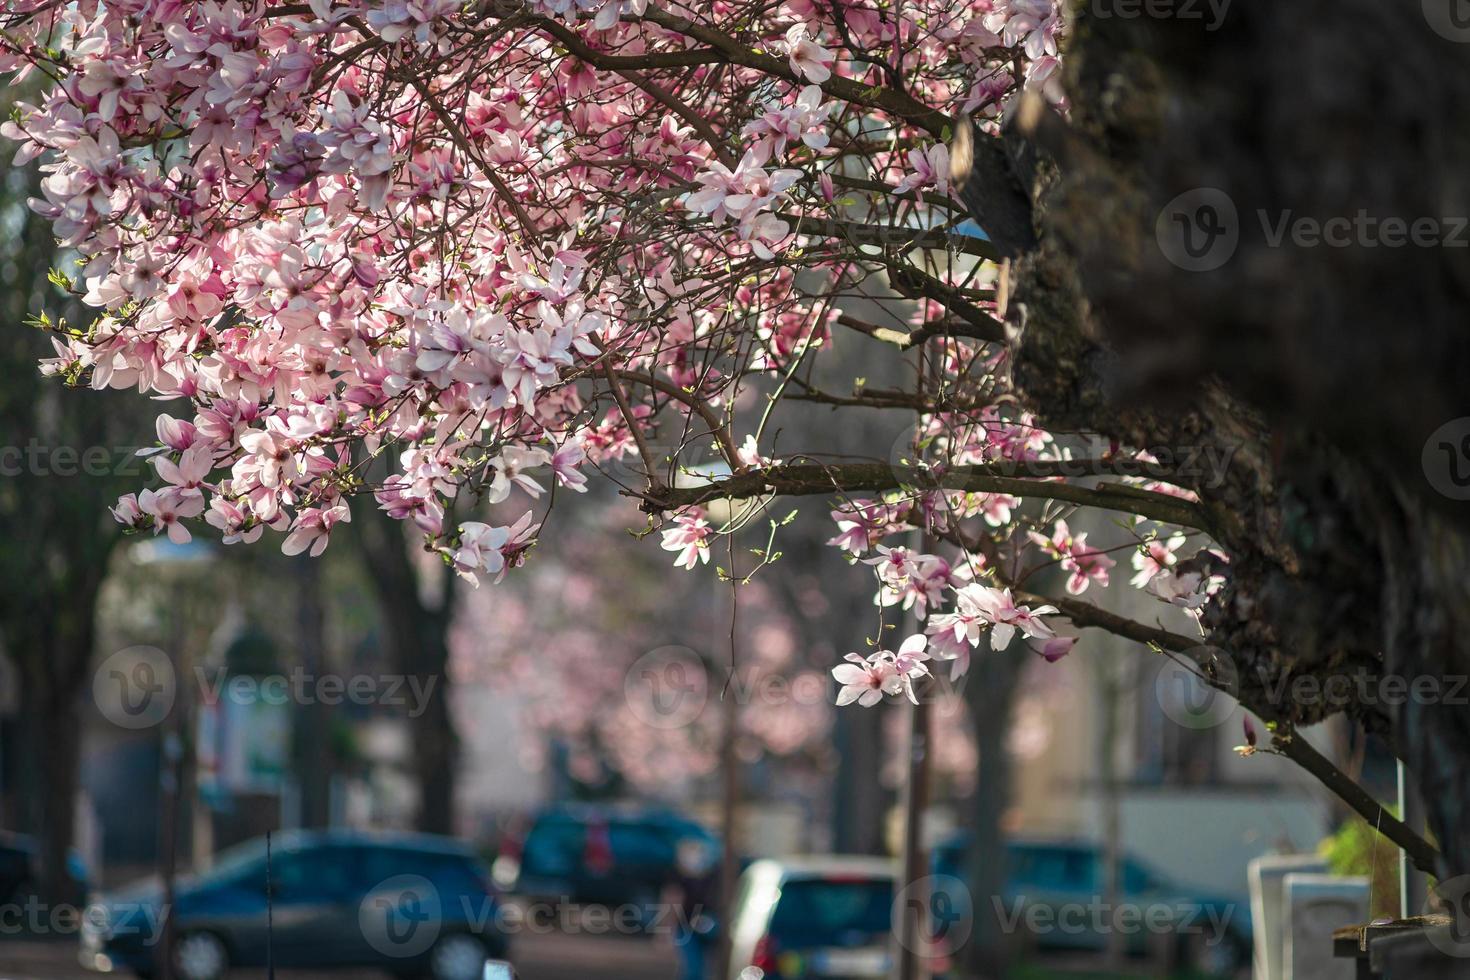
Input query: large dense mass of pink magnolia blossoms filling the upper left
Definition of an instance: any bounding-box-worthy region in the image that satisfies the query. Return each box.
[0,0,1064,590]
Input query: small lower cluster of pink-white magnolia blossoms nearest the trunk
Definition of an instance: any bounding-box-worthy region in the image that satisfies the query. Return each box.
[828,410,1225,707]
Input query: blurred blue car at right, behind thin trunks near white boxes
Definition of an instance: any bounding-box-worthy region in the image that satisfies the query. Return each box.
[932,836,1251,976]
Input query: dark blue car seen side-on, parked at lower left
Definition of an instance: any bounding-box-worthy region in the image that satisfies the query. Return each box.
[81,830,509,980]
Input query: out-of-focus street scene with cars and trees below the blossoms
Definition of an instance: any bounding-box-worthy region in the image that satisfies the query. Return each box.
[0,70,1397,980]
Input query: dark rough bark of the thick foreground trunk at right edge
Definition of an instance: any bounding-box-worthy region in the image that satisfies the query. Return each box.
[1008,0,1470,874]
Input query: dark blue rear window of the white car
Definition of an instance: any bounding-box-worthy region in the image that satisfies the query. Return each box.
[770,879,894,948]
